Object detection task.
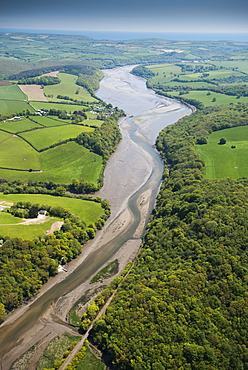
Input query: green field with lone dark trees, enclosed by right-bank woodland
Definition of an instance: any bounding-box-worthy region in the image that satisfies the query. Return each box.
[196,126,248,179]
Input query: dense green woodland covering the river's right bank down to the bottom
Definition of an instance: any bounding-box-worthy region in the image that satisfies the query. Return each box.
[92,104,248,370]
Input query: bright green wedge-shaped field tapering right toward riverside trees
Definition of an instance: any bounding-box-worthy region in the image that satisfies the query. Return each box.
[21,124,94,150]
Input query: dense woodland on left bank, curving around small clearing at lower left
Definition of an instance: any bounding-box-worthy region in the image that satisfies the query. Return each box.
[0,195,110,319]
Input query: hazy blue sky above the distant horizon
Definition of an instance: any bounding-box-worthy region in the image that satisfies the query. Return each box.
[0,0,248,33]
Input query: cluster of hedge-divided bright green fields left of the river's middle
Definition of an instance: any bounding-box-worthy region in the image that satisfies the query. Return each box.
[0,116,102,184]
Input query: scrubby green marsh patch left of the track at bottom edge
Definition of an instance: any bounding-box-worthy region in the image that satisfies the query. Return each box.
[36,334,81,370]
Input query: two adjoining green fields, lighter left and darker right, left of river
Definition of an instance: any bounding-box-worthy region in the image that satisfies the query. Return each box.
[0,140,102,184]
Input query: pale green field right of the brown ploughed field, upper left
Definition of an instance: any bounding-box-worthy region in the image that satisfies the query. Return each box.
[44,73,96,102]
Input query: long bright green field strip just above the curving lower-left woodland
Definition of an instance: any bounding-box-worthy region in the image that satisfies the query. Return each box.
[0,193,104,225]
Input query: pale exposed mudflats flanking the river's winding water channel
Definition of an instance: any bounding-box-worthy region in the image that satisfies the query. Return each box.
[0,66,190,370]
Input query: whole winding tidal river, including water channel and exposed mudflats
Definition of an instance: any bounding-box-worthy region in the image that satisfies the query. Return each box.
[0,66,191,370]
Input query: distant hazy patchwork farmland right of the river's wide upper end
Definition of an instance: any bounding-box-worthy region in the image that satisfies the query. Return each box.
[141,55,248,108]
